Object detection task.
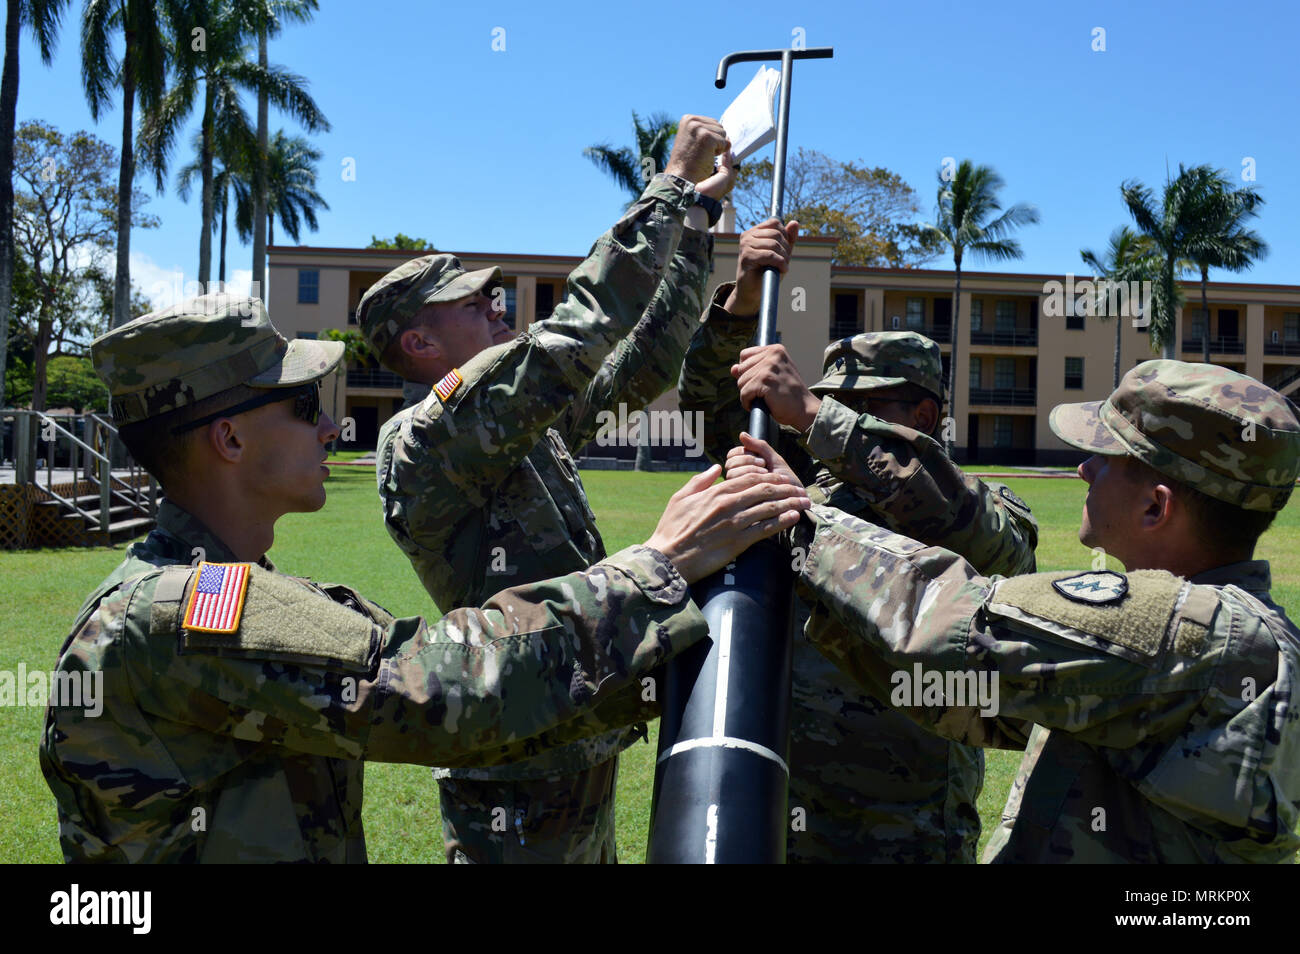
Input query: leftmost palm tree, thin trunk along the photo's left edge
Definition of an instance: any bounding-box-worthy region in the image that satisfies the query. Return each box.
[0,0,68,407]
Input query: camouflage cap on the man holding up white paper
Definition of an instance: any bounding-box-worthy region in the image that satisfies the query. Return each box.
[356,255,501,355]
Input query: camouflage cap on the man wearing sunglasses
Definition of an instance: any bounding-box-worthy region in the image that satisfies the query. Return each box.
[90,292,343,424]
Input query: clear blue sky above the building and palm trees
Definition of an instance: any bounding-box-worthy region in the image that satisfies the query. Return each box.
[18,0,1300,306]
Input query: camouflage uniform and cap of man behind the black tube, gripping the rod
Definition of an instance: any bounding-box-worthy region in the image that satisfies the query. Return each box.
[680,308,1037,863]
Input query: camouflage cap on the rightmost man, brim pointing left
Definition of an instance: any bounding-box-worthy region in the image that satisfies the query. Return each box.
[1048,360,1300,511]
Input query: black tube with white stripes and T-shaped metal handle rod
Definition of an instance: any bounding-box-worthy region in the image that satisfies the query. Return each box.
[646,47,835,864]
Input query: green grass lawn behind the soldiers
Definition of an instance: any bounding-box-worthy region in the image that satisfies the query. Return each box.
[0,467,1300,863]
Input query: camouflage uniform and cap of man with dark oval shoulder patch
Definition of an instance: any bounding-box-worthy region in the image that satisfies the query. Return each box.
[796,361,1300,863]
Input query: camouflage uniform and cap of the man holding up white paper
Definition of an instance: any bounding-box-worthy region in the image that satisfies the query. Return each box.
[358,174,712,862]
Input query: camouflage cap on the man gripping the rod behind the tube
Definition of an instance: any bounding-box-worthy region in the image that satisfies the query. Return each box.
[809,331,944,399]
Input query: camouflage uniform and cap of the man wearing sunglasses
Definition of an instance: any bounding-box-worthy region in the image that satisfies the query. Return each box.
[40,299,707,862]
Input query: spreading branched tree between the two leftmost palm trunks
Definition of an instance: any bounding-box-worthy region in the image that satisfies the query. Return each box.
[14,122,156,411]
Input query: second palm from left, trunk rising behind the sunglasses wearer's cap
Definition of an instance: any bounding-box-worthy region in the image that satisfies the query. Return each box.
[81,0,174,328]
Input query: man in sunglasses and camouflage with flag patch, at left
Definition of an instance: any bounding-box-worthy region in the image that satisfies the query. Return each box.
[40,296,800,862]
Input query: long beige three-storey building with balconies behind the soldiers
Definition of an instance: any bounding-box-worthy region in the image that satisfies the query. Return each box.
[268,234,1300,464]
